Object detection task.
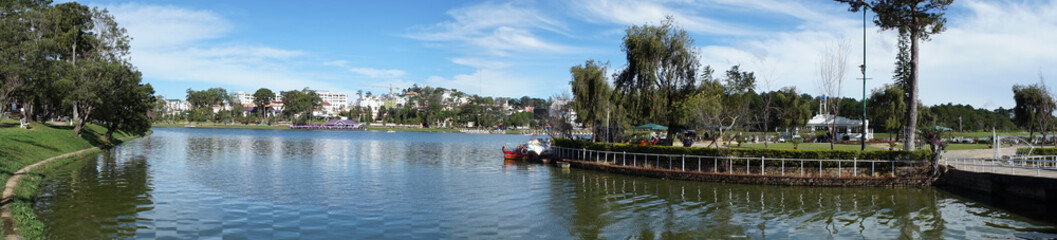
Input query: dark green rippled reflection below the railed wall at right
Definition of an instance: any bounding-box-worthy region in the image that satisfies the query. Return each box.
[552,169,1057,239]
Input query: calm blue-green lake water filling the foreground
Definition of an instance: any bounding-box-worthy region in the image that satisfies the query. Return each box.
[30,128,1057,239]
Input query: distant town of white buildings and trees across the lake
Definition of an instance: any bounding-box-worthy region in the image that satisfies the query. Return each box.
[155,86,553,129]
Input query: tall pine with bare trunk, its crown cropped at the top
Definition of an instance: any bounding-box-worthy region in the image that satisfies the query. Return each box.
[835,0,953,150]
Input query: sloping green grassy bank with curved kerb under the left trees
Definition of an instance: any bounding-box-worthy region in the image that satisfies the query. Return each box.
[0,121,138,239]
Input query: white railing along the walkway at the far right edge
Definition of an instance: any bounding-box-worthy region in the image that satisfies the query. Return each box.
[943,155,1057,177]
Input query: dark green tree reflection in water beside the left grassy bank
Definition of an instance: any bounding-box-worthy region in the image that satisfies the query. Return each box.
[37,151,153,239]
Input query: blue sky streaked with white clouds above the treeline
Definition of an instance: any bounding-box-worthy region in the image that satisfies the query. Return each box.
[78,0,1057,109]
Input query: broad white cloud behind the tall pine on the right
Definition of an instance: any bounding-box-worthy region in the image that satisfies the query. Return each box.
[676,0,1057,108]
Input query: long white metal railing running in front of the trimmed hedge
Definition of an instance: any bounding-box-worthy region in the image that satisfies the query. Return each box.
[551,147,932,178]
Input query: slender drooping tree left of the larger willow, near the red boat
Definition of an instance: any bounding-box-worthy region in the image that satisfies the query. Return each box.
[569,60,613,142]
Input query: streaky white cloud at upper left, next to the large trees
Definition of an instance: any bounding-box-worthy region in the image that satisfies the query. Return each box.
[107,4,337,94]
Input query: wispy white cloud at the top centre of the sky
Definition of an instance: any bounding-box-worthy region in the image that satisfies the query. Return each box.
[407,2,572,56]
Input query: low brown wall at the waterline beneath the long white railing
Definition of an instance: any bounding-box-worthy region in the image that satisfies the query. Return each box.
[562,160,931,186]
